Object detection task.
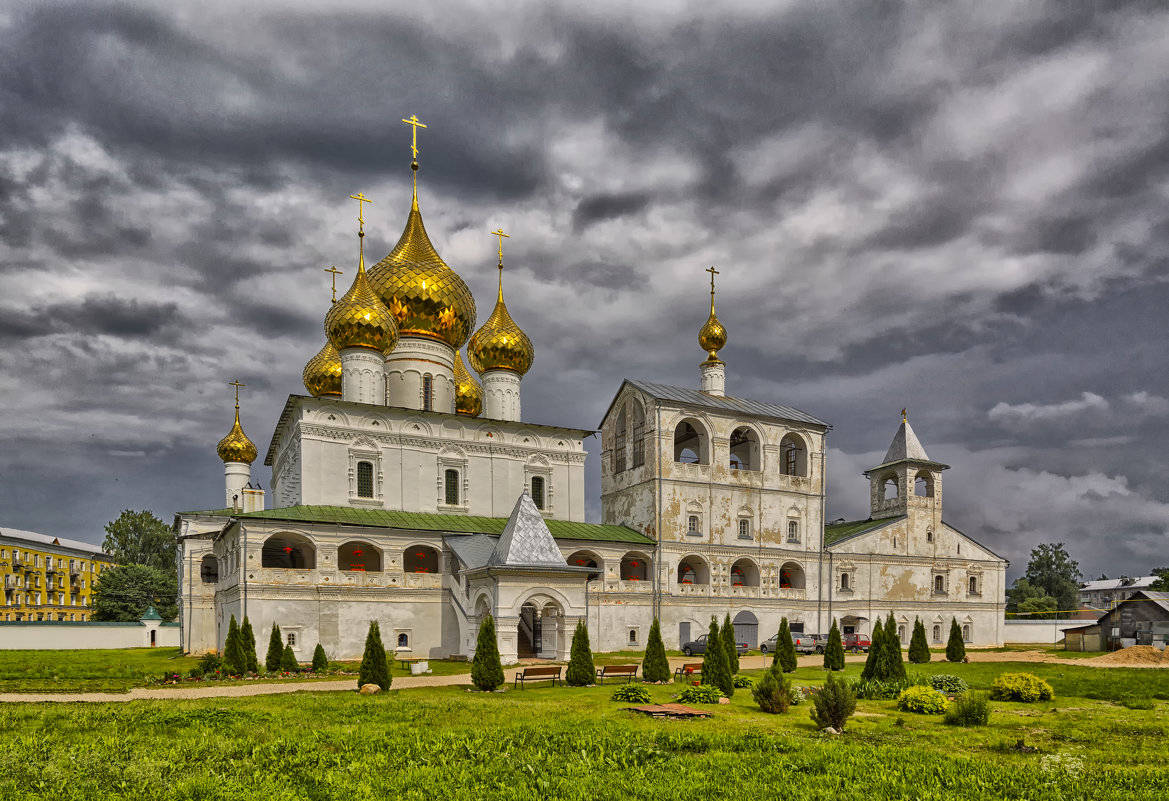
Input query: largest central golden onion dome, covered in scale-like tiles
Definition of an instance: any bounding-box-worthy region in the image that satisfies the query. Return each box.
[369,190,475,351]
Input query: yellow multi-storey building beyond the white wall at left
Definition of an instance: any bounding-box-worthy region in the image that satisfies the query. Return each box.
[0,527,113,622]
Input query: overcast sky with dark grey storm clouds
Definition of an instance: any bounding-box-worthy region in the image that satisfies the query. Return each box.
[0,0,1169,578]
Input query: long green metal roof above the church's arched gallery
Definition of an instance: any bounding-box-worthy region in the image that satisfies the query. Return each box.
[182,506,653,545]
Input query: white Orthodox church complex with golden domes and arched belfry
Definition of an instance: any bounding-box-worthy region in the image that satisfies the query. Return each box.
[175,128,1007,662]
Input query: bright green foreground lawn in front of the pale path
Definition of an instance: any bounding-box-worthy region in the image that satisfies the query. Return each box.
[0,654,1169,801]
